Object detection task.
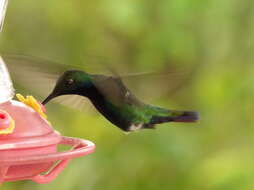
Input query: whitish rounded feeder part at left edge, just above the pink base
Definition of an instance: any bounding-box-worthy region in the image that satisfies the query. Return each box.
[0,57,14,103]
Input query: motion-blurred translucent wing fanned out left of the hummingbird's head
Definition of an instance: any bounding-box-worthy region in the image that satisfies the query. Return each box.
[3,55,65,96]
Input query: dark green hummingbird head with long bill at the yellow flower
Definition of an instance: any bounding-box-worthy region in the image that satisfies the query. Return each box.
[42,70,92,104]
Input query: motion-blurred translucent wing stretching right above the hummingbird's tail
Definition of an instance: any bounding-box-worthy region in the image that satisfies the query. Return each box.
[118,65,198,101]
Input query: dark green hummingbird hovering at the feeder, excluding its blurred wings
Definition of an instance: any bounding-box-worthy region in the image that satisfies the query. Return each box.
[42,70,199,132]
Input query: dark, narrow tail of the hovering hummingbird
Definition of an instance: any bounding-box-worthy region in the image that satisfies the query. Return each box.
[150,110,199,124]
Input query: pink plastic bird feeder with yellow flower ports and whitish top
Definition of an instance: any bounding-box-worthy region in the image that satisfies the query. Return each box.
[0,57,95,183]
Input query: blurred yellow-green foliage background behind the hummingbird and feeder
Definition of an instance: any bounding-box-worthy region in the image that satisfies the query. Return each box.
[0,0,254,190]
